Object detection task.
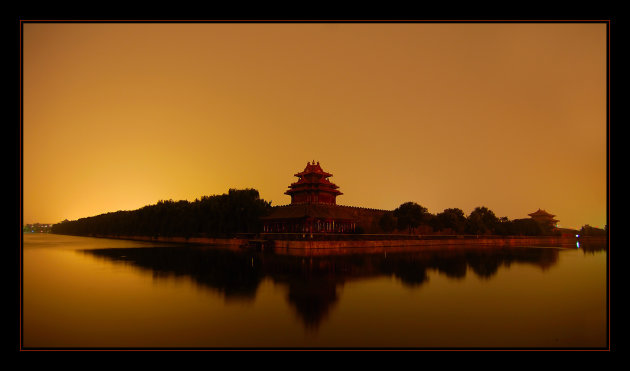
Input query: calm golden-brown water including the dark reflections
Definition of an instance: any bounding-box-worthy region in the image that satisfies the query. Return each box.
[21,234,608,349]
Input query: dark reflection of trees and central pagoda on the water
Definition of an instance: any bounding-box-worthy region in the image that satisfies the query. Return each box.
[84,246,558,329]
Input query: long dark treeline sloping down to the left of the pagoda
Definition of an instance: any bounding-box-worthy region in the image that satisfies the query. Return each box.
[52,189,271,238]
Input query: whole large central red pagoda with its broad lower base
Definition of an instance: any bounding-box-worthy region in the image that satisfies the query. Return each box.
[262,161,387,233]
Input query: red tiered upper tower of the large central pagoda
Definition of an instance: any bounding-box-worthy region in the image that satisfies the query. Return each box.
[284,161,343,205]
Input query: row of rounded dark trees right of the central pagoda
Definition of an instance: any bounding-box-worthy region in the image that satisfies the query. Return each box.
[379,202,560,236]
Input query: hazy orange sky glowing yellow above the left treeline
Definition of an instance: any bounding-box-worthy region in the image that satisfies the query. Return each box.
[22,22,607,227]
